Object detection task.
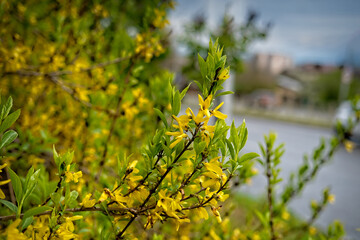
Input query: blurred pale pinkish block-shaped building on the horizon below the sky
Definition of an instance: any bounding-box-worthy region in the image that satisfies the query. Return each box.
[252,53,294,75]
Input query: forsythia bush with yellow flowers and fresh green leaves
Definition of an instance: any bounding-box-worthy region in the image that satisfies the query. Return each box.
[0,0,358,239]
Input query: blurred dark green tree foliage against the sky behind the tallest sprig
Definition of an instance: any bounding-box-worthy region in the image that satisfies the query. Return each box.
[180,11,271,91]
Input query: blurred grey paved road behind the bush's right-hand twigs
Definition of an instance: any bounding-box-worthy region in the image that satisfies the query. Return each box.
[231,116,360,239]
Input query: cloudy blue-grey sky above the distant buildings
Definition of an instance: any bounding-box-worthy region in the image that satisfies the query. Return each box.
[169,0,360,64]
